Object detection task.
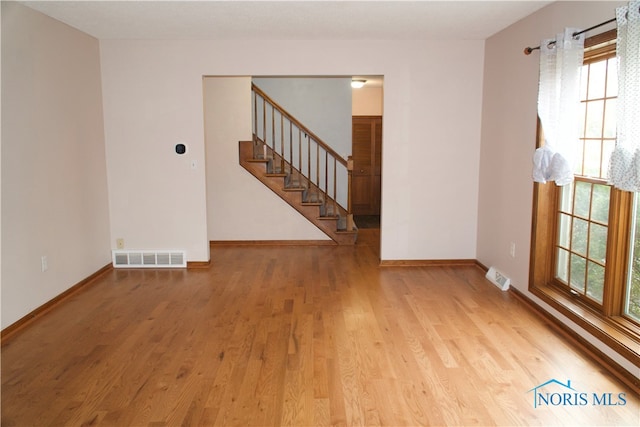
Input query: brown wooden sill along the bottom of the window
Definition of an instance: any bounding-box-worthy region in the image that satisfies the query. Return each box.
[529,285,640,367]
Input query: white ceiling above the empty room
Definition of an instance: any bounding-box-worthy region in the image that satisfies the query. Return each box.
[22,0,552,40]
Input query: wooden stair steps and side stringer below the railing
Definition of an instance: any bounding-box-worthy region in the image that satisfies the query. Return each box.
[239,140,358,245]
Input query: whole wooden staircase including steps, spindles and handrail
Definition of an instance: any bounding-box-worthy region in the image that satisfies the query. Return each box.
[240,84,358,245]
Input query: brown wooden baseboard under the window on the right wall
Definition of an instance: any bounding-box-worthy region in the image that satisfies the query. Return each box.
[508,287,640,394]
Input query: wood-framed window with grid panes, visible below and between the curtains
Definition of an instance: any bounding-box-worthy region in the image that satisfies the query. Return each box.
[530,30,640,363]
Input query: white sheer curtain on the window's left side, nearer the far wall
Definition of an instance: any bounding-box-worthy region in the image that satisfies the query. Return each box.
[533,28,584,185]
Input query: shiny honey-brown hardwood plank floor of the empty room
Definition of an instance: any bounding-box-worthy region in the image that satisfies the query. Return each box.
[2,235,640,426]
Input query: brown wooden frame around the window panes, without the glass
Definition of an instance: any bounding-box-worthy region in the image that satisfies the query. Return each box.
[529,30,640,366]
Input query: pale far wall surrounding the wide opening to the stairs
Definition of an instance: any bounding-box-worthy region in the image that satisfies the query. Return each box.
[100,40,484,260]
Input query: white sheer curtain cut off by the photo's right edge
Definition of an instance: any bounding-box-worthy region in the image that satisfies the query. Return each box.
[609,1,640,191]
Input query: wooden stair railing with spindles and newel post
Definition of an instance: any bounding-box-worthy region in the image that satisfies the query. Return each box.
[251,84,355,231]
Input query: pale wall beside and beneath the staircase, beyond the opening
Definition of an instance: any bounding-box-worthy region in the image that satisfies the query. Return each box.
[204,77,329,241]
